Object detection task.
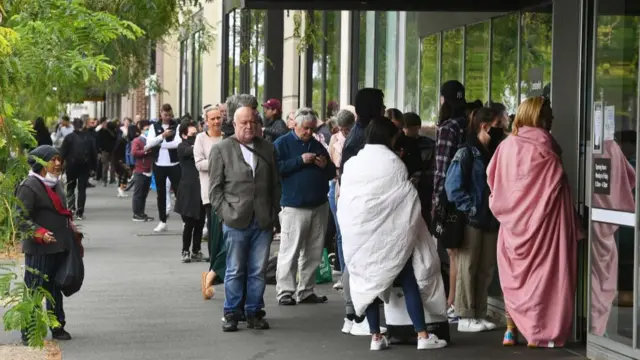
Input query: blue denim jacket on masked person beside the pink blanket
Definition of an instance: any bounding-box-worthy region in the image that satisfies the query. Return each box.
[444,144,499,231]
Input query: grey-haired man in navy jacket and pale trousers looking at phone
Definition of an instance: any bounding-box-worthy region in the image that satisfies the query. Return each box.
[274,108,336,305]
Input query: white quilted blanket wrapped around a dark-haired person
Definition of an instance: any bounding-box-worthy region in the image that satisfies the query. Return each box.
[338,145,446,316]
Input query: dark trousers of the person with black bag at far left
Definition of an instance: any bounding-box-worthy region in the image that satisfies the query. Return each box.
[23,252,68,334]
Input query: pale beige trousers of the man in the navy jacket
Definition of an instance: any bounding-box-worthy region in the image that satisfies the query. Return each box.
[276,202,329,301]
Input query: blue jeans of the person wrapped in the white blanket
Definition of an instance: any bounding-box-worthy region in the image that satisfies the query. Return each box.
[365,258,427,334]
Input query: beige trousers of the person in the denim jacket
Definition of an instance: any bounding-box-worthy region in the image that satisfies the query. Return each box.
[454,225,498,319]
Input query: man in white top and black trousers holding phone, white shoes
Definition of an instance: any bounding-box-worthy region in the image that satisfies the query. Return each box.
[144,104,182,232]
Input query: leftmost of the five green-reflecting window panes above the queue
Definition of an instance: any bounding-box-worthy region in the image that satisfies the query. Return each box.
[420,34,440,124]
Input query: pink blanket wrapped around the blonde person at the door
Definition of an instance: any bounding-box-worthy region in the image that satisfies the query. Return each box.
[487,127,582,347]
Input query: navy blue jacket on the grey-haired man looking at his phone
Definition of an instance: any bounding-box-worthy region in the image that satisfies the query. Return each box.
[273,131,336,208]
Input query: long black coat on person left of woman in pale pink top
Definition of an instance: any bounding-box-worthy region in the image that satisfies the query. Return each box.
[175,141,203,219]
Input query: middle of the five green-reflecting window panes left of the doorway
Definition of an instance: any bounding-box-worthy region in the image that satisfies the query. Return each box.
[464,21,490,103]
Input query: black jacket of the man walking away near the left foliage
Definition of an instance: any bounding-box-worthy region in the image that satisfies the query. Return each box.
[60,131,98,170]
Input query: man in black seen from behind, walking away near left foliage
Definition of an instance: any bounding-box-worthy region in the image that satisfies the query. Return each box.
[60,118,98,220]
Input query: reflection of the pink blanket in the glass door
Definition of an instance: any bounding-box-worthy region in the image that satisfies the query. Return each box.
[591,140,636,336]
